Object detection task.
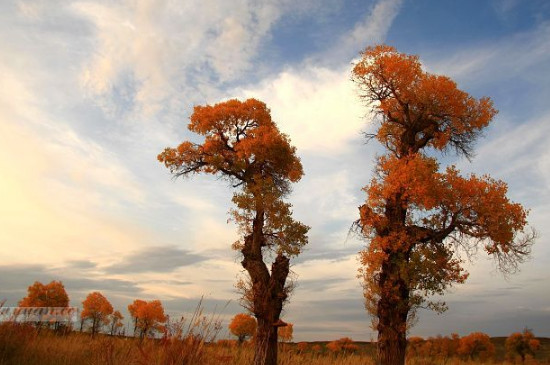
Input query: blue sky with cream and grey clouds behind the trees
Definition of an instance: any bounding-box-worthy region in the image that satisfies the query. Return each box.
[0,0,550,341]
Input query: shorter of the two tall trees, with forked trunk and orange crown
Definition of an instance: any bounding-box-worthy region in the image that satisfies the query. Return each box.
[158,99,309,365]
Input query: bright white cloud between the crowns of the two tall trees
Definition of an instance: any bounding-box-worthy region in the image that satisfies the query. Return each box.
[233,66,365,154]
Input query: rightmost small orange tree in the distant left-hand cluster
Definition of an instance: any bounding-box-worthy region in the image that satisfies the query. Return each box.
[128,299,168,339]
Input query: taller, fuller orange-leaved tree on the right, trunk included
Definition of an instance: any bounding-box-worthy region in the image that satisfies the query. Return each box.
[352,45,535,364]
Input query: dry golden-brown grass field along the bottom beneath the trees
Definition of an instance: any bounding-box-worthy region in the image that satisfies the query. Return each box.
[0,323,550,365]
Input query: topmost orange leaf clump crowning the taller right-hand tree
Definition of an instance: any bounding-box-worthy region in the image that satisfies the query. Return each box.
[353,45,497,157]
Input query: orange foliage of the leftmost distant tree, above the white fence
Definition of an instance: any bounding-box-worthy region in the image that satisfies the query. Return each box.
[19,281,69,307]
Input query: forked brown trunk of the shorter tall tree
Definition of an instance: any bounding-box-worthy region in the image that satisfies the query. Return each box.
[241,205,290,365]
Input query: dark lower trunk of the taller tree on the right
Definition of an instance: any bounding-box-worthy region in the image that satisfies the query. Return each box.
[377,254,409,365]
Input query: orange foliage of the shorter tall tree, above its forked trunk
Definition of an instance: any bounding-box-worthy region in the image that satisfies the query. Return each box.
[158,99,308,255]
